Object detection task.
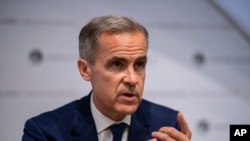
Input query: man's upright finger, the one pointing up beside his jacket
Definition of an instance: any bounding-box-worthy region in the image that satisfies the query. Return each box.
[177,112,192,139]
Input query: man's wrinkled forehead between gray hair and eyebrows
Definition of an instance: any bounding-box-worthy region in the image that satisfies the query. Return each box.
[97,31,147,59]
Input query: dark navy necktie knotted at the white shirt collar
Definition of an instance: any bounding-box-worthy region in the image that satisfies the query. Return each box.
[109,123,127,141]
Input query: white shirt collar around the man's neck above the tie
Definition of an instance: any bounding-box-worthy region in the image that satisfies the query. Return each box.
[90,93,131,133]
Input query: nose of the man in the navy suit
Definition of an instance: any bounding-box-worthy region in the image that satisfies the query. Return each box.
[123,68,138,86]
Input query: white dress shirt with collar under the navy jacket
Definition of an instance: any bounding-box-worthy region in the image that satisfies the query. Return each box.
[90,93,131,141]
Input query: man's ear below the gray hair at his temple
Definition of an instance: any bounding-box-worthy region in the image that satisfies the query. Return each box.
[77,58,91,81]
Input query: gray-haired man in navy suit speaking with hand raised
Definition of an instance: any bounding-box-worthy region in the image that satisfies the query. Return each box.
[22,16,191,141]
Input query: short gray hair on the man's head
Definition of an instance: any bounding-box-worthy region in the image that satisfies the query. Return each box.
[79,15,148,64]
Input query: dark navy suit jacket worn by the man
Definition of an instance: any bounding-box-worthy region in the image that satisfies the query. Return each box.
[22,94,179,141]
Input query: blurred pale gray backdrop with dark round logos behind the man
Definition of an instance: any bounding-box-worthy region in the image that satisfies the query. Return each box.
[0,0,250,141]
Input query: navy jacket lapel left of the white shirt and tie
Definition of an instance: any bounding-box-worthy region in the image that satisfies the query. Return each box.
[71,94,98,141]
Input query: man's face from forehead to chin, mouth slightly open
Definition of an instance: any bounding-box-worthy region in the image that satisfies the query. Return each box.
[89,32,147,120]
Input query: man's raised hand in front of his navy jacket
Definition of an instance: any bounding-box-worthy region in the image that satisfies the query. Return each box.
[150,113,192,141]
